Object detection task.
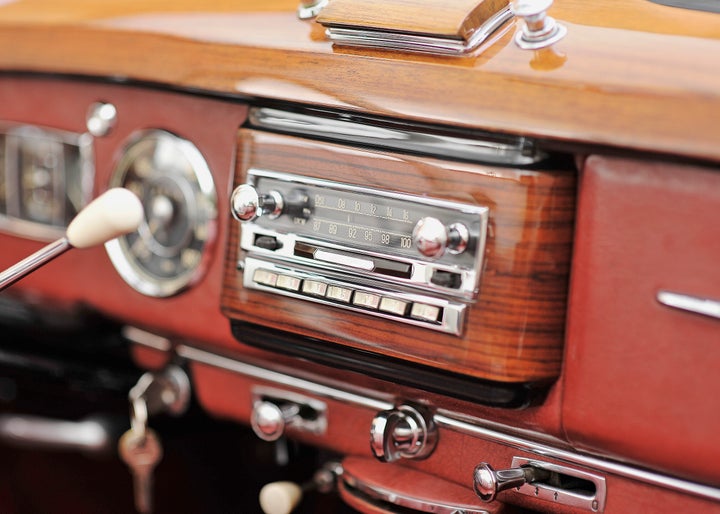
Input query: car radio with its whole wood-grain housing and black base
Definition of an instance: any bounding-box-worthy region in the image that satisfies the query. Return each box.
[221,127,576,388]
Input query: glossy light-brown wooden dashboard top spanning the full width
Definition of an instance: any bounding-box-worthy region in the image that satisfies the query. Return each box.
[0,0,720,161]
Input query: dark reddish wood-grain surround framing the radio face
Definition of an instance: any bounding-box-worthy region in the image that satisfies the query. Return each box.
[222,130,575,382]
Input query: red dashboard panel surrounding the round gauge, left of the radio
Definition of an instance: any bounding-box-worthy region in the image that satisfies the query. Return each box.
[0,78,247,345]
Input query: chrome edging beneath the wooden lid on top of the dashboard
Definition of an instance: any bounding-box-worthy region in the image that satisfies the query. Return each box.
[326,6,513,56]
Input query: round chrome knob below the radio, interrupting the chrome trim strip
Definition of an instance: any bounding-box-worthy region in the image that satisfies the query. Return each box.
[370,405,437,462]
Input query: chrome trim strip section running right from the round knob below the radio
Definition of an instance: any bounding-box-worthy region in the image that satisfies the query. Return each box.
[435,414,720,501]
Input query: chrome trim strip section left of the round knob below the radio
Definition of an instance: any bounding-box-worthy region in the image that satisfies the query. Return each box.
[176,345,394,410]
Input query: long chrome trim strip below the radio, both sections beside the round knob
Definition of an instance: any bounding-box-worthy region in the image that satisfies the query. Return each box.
[176,345,720,501]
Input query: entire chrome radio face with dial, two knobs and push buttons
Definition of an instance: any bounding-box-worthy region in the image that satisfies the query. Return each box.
[232,169,488,335]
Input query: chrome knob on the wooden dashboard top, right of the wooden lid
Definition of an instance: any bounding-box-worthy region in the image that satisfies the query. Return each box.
[510,0,567,50]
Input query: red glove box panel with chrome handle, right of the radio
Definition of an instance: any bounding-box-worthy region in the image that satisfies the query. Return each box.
[563,157,720,485]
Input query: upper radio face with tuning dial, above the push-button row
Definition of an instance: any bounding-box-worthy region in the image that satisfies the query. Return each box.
[240,169,488,290]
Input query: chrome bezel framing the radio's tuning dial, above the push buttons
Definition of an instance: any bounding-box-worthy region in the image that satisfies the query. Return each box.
[239,168,489,302]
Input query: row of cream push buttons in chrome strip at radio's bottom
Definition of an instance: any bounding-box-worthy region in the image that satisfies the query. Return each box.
[243,257,465,335]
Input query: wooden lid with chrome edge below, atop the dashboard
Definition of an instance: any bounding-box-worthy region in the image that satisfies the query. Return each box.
[317,0,508,40]
